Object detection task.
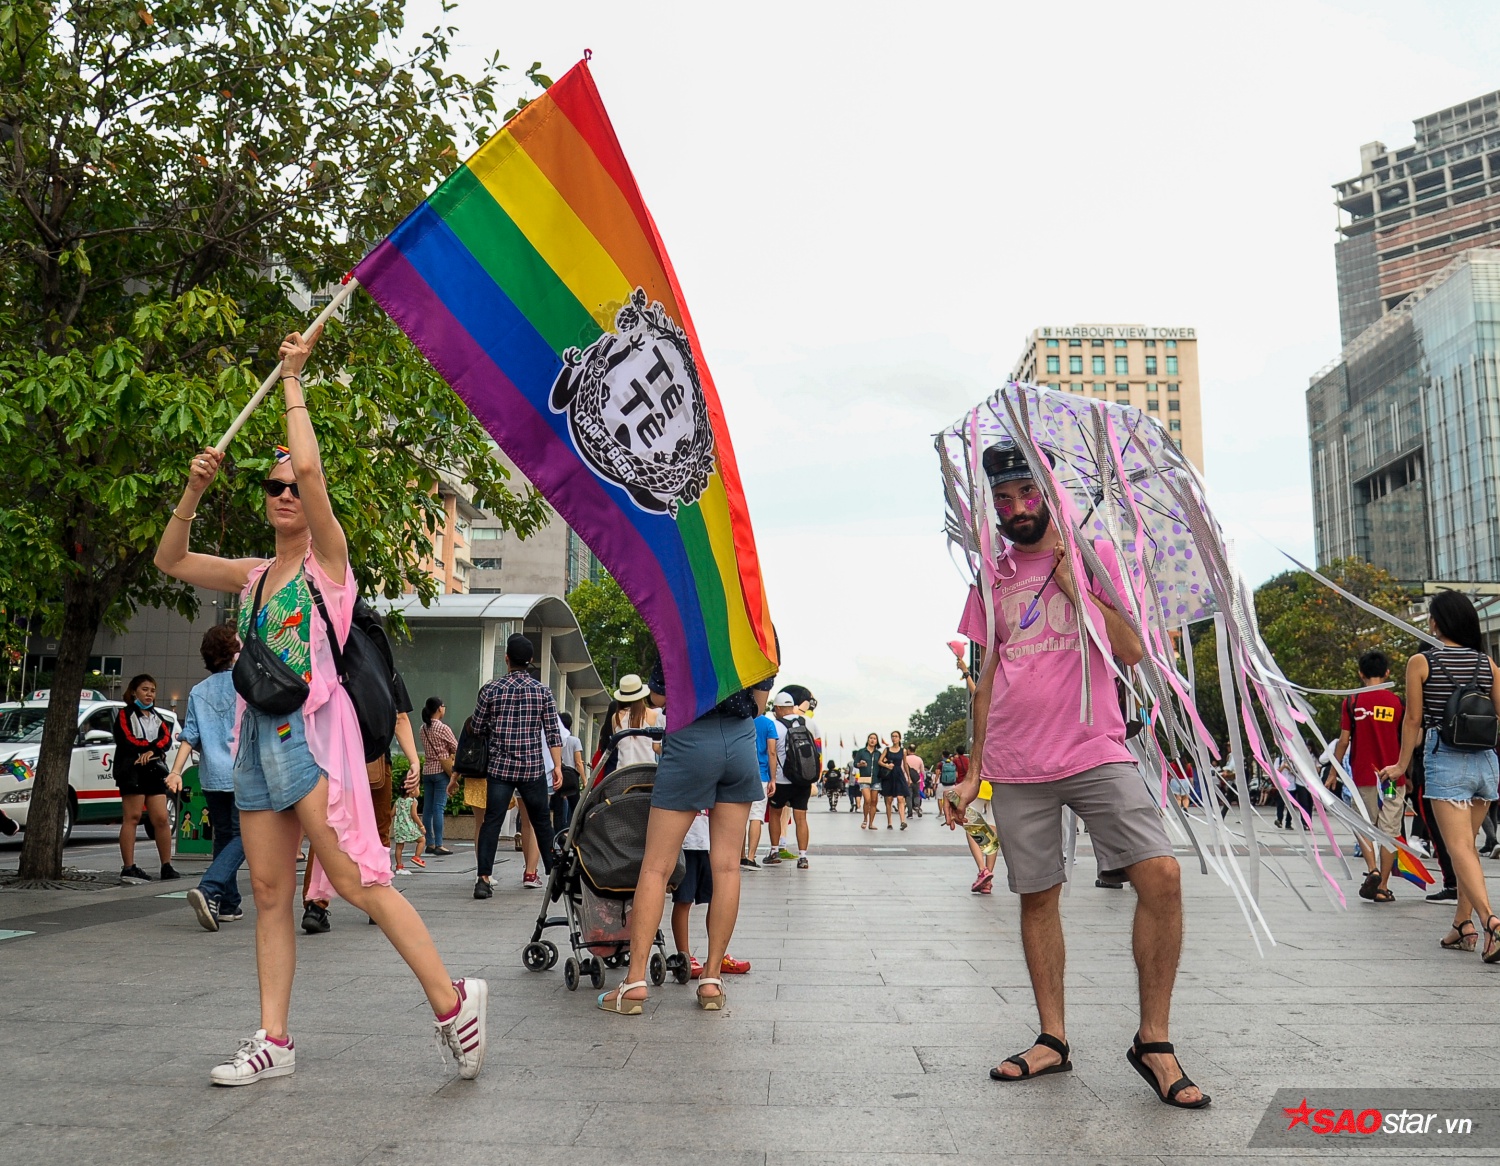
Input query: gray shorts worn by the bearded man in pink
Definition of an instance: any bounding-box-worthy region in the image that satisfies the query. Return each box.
[990,761,1172,894]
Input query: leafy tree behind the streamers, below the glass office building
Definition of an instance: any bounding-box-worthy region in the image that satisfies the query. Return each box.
[1193,558,1416,759]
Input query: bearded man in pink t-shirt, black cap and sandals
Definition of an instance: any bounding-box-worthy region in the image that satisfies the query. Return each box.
[944,443,1209,1109]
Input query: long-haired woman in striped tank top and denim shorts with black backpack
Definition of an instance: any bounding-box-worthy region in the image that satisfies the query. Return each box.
[1380,591,1500,963]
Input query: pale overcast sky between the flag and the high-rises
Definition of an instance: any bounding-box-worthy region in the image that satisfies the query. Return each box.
[410,0,1500,758]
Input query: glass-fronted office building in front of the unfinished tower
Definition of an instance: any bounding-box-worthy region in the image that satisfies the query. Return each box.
[1307,249,1500,584]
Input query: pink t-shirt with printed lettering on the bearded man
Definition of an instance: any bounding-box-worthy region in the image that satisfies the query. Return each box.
[959,542,1136,782]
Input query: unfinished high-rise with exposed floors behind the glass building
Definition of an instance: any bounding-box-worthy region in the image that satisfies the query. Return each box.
[1334,92,1500,345]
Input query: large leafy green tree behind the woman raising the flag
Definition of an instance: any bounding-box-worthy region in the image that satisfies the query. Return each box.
[0,0,546,878]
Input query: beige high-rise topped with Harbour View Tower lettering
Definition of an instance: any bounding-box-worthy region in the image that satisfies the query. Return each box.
[1011,324,1203,471]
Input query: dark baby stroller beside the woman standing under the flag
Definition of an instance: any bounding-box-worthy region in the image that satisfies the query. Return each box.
[521,728,689,992]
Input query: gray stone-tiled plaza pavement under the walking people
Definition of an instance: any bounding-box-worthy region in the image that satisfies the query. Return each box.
[0,810,1500,1166]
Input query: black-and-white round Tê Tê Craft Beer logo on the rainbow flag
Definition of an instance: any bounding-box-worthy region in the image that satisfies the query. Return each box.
[549,287,714,516]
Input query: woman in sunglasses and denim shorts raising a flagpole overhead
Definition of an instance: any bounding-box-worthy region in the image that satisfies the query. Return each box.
[156,326,488,1085]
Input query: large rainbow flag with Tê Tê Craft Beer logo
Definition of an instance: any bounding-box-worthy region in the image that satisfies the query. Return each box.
[354,62,776,726]
